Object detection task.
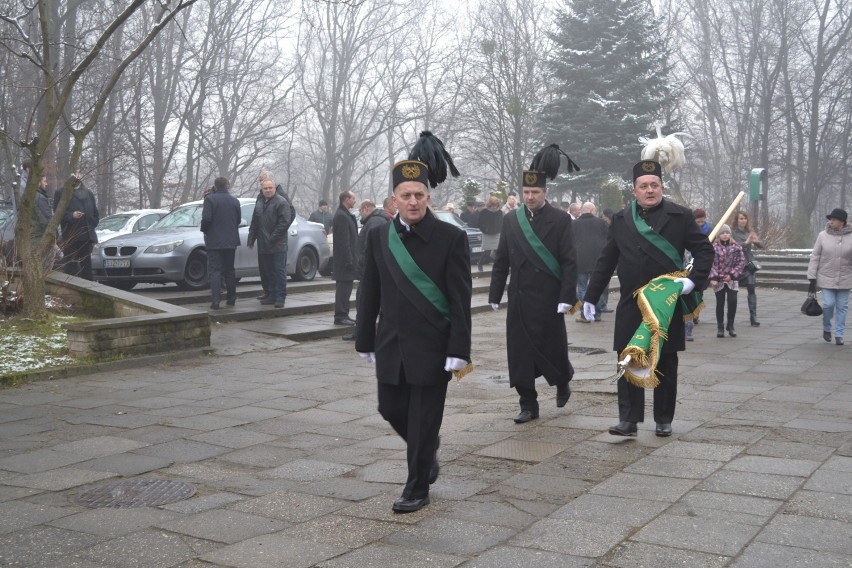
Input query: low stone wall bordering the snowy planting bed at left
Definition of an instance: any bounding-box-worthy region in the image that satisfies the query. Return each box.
[45,272,210,361]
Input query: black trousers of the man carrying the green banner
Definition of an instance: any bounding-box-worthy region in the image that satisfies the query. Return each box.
[618,351,678,424]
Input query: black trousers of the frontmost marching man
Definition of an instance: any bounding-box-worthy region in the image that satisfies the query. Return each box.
[379,369,448,499]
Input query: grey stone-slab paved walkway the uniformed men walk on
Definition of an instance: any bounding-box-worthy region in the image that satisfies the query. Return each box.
[0,289,852,568]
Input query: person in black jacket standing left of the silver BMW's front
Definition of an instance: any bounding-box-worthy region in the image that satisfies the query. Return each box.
[53,175,100,280]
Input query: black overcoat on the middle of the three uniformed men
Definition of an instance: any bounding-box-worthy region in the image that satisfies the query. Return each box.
[488,203,577,387]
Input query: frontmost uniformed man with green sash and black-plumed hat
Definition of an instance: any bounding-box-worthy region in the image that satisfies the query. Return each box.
[355,132,471,513]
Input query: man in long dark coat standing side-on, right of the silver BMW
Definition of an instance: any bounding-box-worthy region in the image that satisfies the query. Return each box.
[331,191,358,325]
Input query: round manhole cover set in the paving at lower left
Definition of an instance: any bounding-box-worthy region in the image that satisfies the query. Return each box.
[74,479,195,509]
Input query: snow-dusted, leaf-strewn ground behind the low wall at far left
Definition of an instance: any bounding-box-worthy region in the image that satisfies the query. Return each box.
[0,296,83,377]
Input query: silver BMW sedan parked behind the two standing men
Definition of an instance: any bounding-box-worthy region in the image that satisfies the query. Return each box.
[92,198,329,290]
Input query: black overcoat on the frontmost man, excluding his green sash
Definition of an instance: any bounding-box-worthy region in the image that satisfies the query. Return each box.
[354,211,472,386]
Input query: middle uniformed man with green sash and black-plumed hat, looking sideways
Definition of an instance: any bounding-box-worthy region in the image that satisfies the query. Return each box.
[488,145,577,424]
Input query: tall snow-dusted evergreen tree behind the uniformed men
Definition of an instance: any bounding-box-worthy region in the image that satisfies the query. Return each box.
[540,0,674,195]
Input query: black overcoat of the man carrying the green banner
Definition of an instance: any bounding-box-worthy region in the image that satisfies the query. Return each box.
[585,199,714,353]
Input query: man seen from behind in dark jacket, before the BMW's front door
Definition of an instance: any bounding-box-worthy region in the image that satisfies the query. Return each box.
[201,177,242,310]
